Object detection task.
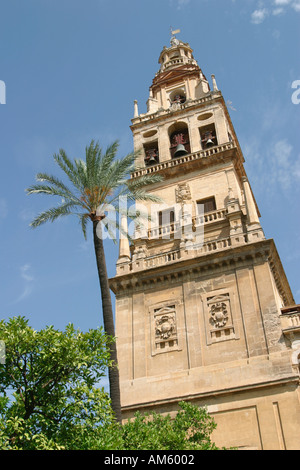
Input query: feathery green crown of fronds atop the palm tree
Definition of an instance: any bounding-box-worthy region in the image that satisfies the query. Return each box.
[26,140,162,242]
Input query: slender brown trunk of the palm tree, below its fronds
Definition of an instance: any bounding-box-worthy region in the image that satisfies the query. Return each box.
[93,220,122,423]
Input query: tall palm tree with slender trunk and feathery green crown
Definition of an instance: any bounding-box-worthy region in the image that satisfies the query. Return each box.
[26,140,161,422]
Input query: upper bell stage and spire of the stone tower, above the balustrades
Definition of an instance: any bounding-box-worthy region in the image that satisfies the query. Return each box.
[131,37,245,174]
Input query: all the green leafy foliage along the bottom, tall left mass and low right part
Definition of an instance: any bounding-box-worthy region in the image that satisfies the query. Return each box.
[0,317,223,451]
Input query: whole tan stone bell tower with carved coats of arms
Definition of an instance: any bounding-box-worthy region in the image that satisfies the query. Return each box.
[110,37,300,450]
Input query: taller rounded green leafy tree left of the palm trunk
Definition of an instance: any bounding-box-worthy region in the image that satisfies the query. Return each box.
[0,317,112,450]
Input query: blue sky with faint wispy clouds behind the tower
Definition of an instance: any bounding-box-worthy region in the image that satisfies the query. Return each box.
[0,0,300,336]
